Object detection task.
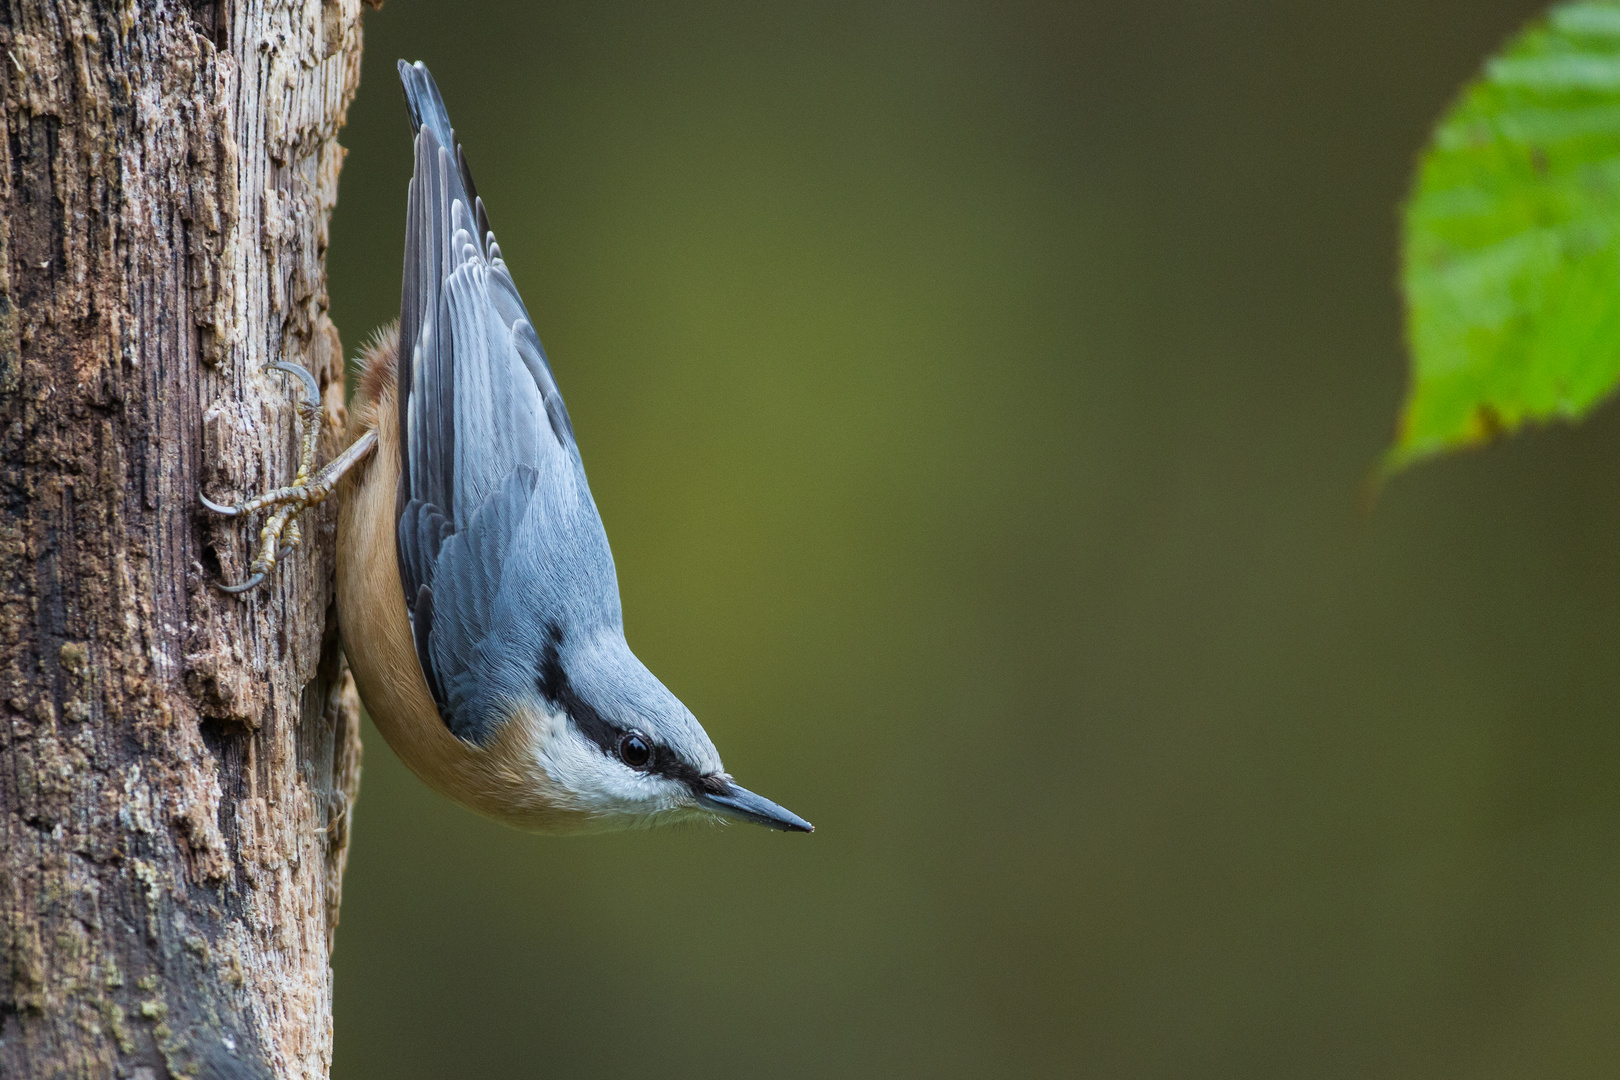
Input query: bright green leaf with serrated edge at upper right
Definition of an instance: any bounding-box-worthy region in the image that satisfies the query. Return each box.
[1383,0,1620,474]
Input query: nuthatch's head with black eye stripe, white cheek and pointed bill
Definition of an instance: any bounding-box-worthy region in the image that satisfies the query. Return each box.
[521,630,813,832]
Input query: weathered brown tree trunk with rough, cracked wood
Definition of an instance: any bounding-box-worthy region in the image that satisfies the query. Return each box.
[0,0,360,1080]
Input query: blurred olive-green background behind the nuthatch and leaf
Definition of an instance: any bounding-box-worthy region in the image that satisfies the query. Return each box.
[329,0,1620,1080]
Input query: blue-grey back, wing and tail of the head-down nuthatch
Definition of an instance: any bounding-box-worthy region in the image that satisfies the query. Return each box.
[395,62,620,742]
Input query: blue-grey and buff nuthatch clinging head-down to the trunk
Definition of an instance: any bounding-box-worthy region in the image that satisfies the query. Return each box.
[204,60,812,832]
